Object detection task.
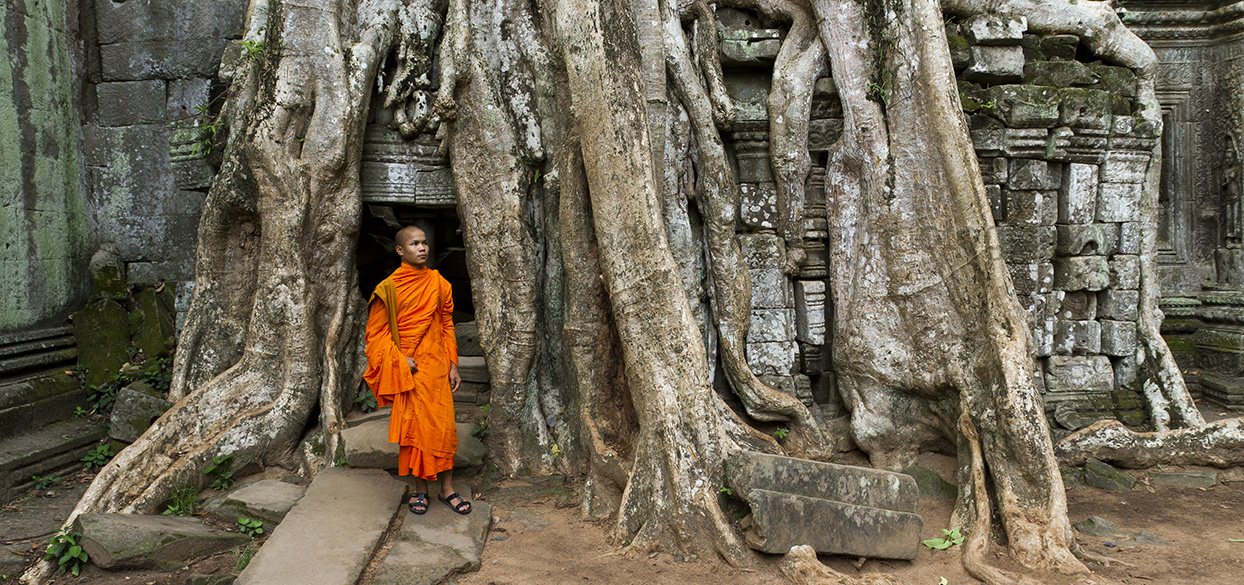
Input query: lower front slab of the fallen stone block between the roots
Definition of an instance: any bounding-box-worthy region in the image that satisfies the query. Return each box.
[744,489,924,560]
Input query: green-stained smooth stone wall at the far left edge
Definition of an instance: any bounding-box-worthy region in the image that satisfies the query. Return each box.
[0,0,91,332]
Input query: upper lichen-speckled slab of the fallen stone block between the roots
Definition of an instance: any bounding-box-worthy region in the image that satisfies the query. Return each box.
[725,451,921,510]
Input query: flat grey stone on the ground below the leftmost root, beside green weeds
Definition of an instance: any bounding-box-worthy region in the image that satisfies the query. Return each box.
[73,514,250,571]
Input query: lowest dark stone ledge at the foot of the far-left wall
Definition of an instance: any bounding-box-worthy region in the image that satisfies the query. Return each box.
[0,421,108,502]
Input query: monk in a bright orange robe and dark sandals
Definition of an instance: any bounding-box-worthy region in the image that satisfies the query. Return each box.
[363,225,470,514]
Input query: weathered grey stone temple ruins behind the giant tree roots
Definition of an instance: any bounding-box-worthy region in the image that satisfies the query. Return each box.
[0,0,1244,495]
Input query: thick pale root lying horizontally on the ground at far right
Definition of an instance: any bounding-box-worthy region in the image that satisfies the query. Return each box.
[1054,418,1244,469]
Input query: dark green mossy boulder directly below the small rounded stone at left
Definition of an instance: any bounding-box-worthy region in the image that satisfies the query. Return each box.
[73,299,129,387]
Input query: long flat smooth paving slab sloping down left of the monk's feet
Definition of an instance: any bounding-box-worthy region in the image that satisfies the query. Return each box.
[236,467,407,585]
